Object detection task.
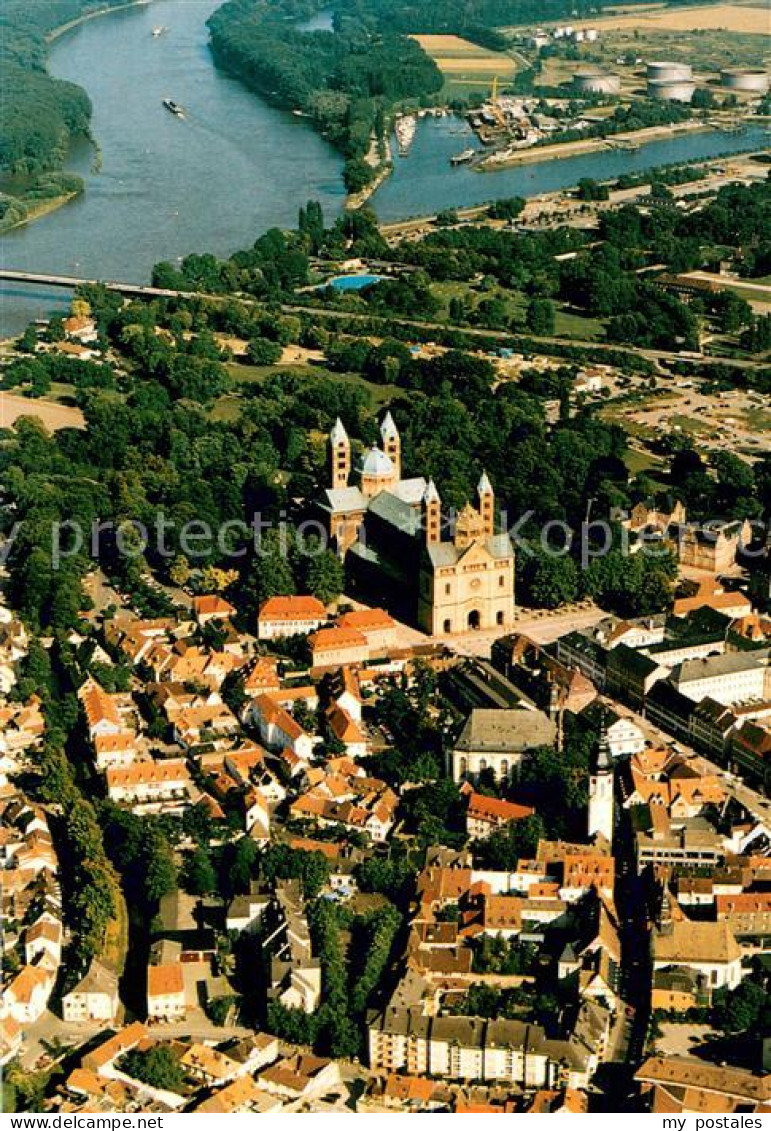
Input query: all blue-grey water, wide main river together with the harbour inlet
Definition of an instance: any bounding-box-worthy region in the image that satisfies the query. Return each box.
[0,0,765,335]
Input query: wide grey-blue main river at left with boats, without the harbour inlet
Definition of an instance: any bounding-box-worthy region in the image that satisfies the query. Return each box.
[0,0,345,335]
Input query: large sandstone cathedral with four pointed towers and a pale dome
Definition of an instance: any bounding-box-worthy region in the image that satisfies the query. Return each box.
[320,413,514,636]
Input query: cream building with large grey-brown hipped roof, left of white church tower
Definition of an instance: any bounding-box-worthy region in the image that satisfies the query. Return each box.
[450,708,556,782]
